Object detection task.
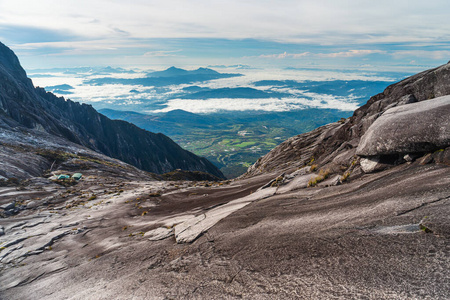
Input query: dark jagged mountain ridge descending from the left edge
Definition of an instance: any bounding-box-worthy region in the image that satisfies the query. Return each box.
[0,43,223,178]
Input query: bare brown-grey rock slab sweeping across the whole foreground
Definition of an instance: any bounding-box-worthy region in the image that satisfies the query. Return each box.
[0,156,450,299]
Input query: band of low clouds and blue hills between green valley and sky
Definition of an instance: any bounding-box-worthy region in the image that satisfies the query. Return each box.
[29,67,400,114]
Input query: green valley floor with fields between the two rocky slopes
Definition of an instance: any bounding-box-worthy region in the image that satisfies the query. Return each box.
[101,108,350,178]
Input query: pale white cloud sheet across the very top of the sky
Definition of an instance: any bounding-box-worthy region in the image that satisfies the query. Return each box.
[0,0,450,45]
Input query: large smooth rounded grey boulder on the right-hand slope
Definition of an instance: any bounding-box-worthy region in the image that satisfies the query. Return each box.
[356,96,450,157]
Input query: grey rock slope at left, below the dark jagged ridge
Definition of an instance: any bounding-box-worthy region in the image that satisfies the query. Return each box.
[0,124,159,180]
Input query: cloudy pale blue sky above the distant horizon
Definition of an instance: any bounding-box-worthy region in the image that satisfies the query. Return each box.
[0,0,450,71]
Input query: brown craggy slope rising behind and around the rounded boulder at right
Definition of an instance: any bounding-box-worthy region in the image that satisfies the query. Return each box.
[243,64,450,177]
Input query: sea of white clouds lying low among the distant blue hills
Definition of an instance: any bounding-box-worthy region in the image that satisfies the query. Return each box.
[28,68,393,114]
